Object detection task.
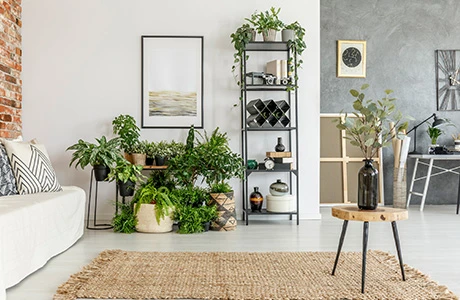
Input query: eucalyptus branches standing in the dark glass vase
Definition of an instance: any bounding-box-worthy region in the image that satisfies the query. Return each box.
[335,84,409,159]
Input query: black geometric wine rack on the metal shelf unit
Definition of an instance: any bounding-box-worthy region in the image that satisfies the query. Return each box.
[246,99,291,128]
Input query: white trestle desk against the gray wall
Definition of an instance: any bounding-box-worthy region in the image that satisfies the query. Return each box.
[407,154,460,214]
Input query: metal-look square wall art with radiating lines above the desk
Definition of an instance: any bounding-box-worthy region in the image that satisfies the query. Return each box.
[435,50,460,110]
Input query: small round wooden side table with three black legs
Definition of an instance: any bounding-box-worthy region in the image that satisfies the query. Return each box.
[332,206,408,293]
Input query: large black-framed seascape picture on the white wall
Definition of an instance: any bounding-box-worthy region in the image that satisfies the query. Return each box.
[141,36,203,128]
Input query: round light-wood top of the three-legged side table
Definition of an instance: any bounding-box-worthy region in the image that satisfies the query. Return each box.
[332,205,409,222]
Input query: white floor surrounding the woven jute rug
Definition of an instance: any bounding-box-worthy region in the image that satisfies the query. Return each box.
[7,205,460,300]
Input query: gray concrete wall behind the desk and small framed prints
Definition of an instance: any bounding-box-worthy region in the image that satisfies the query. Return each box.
[321,0,460,204]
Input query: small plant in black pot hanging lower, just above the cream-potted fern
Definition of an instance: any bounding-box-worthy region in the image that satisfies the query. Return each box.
[108,157,145,197]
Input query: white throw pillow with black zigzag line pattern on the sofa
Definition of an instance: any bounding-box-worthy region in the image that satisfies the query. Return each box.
[3,141,62,195]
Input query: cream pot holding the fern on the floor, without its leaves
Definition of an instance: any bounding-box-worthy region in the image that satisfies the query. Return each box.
[136,204,173,233]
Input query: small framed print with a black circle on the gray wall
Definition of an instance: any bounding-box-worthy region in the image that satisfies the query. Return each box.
[337,41,366,78]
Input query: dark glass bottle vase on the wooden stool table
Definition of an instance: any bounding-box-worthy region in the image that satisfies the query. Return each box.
[358,159,379,210]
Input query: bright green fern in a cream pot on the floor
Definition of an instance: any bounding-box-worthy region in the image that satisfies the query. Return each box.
[133,181,174,233]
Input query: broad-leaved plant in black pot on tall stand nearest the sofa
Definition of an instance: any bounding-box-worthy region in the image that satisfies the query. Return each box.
[66,136,121,181]
